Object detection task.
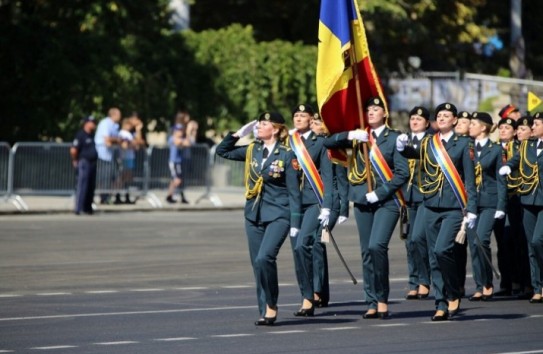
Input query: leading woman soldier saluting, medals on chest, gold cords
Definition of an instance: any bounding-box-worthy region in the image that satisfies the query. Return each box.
[216,112,300,326]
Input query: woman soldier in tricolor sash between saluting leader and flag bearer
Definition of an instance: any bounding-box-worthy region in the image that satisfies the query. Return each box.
[289,104,333,317]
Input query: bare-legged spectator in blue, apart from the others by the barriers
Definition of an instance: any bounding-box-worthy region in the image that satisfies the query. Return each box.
[166,123,191,204]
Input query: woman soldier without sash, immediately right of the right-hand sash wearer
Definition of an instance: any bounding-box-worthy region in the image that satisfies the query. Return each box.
[468,112,507,301]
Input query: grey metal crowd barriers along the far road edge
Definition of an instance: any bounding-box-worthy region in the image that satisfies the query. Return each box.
[0,142,244,210]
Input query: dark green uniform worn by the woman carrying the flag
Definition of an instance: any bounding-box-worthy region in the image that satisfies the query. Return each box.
[325,127,409,309]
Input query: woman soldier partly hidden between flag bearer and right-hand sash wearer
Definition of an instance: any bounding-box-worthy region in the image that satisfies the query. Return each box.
[403,106,430,300]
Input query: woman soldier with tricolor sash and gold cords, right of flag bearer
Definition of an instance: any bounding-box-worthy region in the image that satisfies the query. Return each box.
[397,103,477,321]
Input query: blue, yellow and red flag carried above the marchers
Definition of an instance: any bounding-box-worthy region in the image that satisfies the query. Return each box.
[317,0,388,133]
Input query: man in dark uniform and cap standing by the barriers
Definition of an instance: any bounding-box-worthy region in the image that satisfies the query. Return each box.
[70,116,98,215]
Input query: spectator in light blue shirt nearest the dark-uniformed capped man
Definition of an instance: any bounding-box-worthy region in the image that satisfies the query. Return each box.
[94,107,121,204]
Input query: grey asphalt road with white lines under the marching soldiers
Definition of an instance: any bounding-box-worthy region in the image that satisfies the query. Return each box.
[0,203,543,354]
